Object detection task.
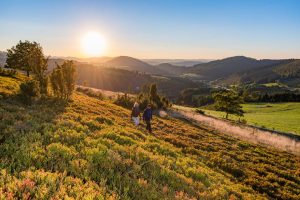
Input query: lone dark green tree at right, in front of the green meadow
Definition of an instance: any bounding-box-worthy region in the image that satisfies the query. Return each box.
[213,90,244,119]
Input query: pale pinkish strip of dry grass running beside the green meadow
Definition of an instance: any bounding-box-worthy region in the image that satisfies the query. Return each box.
[169,109,300,156]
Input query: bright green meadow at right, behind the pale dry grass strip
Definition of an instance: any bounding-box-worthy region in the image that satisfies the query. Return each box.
[199,103,300,135]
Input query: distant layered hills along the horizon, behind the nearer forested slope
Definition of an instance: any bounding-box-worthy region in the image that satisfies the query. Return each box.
[0,52,300,87]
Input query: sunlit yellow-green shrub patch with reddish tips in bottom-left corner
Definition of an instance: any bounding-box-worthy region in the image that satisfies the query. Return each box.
[0,170,117,200]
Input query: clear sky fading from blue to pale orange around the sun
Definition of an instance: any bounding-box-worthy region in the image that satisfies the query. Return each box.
[0,0,300,59]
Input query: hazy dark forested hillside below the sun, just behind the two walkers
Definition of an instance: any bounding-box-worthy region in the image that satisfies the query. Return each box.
[49,59,201,100]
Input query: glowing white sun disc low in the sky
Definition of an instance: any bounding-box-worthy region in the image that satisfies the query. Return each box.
[82,32,106,56]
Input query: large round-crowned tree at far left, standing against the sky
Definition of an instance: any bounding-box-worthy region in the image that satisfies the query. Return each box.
[6,40,47,76]
